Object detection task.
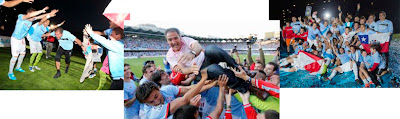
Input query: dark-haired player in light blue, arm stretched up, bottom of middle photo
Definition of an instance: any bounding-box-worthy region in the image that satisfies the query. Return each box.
[136,69,212,119]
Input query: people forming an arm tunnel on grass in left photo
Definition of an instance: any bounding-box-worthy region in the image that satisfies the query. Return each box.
[4,0,124,90]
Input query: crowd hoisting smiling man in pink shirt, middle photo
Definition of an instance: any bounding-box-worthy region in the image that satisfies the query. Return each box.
[124,28,279,119]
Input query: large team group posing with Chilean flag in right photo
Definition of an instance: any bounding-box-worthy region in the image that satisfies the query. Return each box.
[280,4,393,87]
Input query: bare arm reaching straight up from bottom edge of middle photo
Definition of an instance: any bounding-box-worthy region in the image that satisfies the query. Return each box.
[208,75,228,119]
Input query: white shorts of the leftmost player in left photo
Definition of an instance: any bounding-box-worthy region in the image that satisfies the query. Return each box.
[11,37,26,57]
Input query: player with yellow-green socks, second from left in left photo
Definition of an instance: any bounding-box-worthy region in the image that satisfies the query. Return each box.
[26,10,64,72]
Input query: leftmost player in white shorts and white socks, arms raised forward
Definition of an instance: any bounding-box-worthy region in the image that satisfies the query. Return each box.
[8,7,49,80]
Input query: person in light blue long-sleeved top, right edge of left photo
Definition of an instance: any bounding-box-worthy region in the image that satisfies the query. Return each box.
[85,24,124,90]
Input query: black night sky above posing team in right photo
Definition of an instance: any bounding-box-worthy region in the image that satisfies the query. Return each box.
[269,0,400,33]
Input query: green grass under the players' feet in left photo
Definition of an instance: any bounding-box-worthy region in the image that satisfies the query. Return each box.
[0,48,111,90]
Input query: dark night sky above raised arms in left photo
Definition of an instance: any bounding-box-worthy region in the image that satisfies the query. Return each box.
[0,0,111,37]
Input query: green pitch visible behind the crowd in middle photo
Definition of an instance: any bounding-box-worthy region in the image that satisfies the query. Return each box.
[125,54,274,78]
